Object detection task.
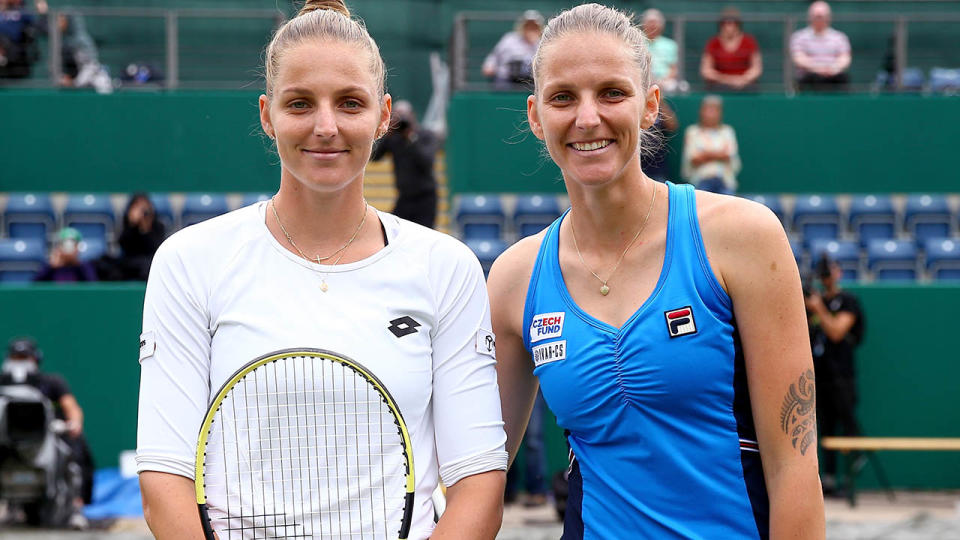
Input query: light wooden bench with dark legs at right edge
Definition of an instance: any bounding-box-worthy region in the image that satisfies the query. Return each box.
[820,437,960,506]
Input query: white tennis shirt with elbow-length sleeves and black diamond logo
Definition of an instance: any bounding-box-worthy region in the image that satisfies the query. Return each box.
[137,202,507,538]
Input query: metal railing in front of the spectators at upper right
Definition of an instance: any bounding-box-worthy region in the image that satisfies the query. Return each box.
[450,11,960,95]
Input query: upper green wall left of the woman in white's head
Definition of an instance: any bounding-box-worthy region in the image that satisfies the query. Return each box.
[0,90,280,192]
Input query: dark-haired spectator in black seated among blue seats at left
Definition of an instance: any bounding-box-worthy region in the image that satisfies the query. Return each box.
[96,193,167,281]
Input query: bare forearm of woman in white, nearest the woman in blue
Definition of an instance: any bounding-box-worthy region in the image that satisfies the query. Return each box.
[430,471,507,540]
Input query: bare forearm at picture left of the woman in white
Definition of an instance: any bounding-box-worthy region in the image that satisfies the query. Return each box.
[140,471,204,540]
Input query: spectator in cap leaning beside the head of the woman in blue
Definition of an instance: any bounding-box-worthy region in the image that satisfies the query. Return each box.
[483,9,543,90]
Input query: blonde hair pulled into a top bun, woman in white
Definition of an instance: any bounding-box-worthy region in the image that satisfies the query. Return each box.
[263,0,387,98]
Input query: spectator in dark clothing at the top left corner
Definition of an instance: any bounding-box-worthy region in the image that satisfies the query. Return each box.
[0,0,48,79]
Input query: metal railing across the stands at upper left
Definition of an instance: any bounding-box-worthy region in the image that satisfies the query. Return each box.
[0,7,286,89]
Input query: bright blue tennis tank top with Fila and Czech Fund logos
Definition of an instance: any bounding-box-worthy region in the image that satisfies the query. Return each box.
[523,182,769,540]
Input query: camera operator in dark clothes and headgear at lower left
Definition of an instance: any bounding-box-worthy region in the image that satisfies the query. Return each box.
[0,337,94,529]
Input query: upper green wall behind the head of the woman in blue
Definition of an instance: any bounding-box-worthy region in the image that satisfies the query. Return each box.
[447,93,960,193]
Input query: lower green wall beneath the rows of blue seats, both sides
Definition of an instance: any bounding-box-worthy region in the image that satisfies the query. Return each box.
[0,285,960,488]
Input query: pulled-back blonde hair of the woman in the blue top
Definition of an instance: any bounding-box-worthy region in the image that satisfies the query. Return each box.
[533,4,651,93]
